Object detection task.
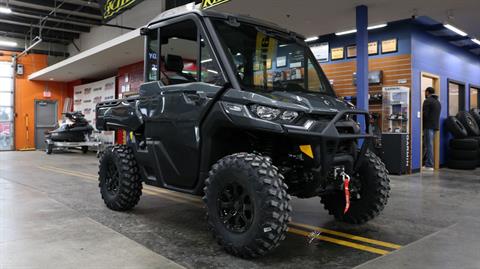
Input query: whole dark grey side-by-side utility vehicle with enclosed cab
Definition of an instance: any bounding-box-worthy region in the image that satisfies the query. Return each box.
[96,6,390,258]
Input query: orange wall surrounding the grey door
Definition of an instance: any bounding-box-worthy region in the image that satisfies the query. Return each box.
[0,52,71,150]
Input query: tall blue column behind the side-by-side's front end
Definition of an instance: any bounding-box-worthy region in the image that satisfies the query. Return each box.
[356,5,368,111]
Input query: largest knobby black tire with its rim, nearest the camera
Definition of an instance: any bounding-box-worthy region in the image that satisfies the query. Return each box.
[203,153,292,258]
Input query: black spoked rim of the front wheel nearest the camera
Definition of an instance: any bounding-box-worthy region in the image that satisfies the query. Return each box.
[218,182,254,233]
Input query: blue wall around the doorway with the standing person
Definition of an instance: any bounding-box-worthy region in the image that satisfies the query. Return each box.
[412,29,480,169]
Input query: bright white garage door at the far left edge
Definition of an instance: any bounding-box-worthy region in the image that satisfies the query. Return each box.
[0,62,14,151]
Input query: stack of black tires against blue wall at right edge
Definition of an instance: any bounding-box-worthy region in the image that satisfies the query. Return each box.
[446,109,480,170]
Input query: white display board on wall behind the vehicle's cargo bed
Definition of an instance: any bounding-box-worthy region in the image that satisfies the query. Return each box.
[73,77,115,143]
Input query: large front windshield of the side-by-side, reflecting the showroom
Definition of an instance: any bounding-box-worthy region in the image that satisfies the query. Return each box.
[212,19,334,95]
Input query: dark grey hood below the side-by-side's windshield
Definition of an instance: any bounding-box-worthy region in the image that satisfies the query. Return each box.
[251,91,350,113]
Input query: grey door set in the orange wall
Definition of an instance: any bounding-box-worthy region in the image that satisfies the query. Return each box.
[35,100,57,150]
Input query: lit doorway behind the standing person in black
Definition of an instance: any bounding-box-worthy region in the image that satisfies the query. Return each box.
[420,72,440,170]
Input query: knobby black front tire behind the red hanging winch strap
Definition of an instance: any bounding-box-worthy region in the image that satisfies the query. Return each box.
[320,151,390,224]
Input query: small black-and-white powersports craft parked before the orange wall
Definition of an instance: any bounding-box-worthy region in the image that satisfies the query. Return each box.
[45,111,93,154]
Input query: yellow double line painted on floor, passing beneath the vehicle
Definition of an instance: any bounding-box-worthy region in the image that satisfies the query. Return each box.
[38,163,401,255]
